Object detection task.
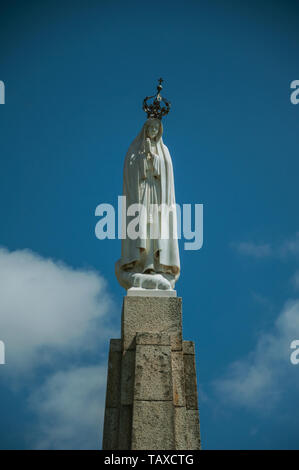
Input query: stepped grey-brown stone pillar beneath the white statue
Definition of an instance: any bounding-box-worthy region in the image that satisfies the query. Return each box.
[103,295,200,450]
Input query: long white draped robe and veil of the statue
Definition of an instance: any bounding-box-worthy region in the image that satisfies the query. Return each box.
[118,119,180,276]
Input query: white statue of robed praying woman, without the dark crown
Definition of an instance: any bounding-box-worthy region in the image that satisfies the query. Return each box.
[115,118,180,290]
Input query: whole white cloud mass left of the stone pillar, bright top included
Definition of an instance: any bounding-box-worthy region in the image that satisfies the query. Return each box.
[0,248,119,449]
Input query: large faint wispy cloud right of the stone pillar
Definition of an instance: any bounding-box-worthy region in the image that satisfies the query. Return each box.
[214,300,299,409]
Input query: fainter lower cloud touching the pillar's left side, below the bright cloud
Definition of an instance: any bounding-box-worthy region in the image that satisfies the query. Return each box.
[30,366,106,450]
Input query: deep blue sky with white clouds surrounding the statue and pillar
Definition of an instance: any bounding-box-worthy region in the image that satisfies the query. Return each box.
[0,0,299,449]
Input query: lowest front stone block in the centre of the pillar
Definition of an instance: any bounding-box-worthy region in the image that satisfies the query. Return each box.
[132,401,175,450]
